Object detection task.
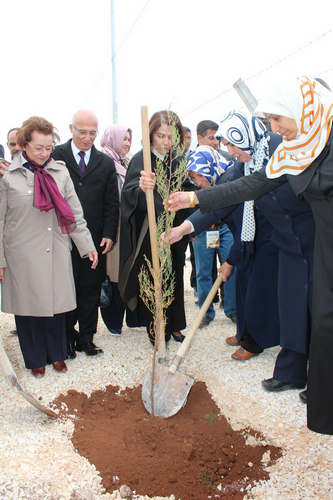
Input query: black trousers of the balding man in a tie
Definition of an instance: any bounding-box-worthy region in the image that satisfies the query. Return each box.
[66,284,101,344]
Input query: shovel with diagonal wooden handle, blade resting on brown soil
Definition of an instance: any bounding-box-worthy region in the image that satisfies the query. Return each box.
[141,273,223,418]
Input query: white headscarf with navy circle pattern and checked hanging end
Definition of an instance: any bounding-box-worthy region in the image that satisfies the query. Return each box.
[216,111,269,241]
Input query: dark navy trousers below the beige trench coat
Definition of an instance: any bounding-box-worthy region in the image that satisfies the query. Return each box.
[15,313,67,370]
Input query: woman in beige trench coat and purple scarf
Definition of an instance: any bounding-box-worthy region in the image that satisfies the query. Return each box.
[0,117,98,377]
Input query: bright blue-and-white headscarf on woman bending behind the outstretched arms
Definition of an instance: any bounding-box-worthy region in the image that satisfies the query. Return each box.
[187,146,233,186]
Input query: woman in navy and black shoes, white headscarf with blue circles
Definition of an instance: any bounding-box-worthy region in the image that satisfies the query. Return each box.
[169,111,314,391]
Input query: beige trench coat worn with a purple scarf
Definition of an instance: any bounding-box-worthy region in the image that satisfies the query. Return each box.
[0,155,95,317]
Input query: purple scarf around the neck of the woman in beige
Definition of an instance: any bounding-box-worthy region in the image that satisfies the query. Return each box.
[22,151,76,234]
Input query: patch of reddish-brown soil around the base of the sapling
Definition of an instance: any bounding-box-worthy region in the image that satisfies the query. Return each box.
[55,382,281,500]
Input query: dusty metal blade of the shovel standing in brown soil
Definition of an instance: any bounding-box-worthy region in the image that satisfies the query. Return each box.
[141,364,194,418]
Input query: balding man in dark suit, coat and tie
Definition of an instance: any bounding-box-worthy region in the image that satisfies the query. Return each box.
[52,110,119,359]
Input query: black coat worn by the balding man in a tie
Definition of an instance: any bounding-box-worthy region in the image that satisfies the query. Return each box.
[52,139,119,285]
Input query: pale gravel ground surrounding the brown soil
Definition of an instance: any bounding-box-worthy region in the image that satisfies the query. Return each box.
[0,258,333,500]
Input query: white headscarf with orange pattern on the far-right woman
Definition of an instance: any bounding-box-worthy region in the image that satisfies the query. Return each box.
[255,76,333,178]
